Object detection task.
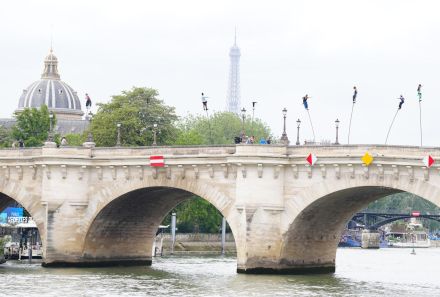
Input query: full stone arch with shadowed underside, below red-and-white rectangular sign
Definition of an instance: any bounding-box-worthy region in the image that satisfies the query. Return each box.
[82,178,240,266]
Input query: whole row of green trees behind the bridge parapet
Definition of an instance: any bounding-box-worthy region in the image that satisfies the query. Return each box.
[0,87,271,147]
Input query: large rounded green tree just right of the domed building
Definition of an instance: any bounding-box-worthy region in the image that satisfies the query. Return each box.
[90,87,178,146]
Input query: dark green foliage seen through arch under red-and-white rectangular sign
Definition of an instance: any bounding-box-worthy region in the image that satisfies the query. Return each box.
[162,196,222,233]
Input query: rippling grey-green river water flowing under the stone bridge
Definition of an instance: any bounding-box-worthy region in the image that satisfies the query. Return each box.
[0,248,440,297]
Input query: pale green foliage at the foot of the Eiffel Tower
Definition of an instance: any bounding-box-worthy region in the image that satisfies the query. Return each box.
[176,112,271,144]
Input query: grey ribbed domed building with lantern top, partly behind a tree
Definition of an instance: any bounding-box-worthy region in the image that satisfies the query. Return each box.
[0,48,89,135]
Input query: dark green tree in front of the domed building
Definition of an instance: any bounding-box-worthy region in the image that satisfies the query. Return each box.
[12,105,56,147]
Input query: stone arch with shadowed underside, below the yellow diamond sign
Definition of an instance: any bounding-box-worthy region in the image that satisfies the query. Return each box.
[279,176,440,272]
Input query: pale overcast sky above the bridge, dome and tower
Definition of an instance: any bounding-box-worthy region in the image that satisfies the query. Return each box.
[0,0,440,146]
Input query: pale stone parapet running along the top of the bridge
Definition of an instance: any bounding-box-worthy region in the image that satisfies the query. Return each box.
[0,144,440,162]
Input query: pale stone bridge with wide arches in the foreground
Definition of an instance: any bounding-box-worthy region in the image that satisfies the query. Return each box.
[0,145,440,273]
